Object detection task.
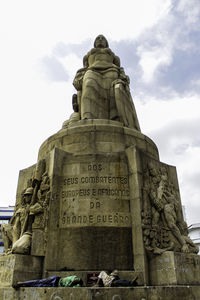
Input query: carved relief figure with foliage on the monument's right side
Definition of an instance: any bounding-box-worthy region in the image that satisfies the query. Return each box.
[143,164,198,254]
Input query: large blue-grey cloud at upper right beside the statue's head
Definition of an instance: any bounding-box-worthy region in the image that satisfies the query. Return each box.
[107,3,200,100]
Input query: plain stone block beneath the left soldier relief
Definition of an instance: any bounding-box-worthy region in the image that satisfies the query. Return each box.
[0,254,43,288]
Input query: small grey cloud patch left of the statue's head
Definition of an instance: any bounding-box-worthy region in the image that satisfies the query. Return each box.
[40,56,69,81]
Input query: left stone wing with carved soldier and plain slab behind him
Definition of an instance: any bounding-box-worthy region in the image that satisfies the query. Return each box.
[1,160,50,255]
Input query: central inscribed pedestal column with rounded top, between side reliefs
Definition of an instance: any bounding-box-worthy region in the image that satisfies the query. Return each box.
[39,120,158,284]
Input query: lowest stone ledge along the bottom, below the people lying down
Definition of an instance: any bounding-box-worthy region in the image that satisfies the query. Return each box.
[0,286,200,300]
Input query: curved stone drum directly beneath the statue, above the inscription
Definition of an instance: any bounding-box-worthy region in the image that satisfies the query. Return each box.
[38,120,159,160]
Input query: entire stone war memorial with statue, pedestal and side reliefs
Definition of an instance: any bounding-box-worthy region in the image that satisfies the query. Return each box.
[0,35,200,300]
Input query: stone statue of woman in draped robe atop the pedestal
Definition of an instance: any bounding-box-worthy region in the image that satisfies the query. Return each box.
[73,35,140,131]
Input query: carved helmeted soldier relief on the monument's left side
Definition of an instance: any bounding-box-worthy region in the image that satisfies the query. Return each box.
[2,161,50,254]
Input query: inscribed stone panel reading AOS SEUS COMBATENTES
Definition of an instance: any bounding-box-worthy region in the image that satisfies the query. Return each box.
[59,154,131,228]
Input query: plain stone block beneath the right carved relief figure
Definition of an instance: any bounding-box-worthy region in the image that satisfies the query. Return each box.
[150,251,200,285]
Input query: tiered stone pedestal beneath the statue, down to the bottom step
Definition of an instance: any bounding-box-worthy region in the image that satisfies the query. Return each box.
[0,120,200,300]
